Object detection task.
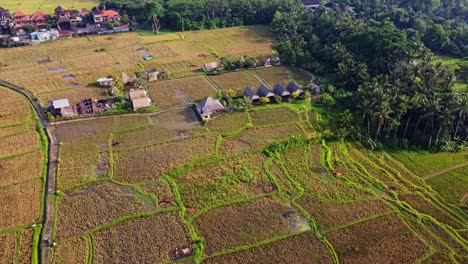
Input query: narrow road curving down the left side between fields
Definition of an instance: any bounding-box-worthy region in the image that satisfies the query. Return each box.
[0,81,58,263]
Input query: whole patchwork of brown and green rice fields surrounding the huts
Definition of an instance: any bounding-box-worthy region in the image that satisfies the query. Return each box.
[0,25,468,263]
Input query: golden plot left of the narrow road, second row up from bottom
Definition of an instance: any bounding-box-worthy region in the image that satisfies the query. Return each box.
[0,180,43,231]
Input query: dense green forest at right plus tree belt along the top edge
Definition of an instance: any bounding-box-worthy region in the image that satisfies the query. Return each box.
[101,0,468,151]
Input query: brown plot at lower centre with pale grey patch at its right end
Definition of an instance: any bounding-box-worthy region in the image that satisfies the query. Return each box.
[194,198,310,255]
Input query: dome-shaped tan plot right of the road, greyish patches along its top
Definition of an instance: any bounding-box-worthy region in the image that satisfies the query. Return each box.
[56,182,155,239]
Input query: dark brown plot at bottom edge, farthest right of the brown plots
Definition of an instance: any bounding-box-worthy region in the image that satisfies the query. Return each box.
[327,215,429,263]
